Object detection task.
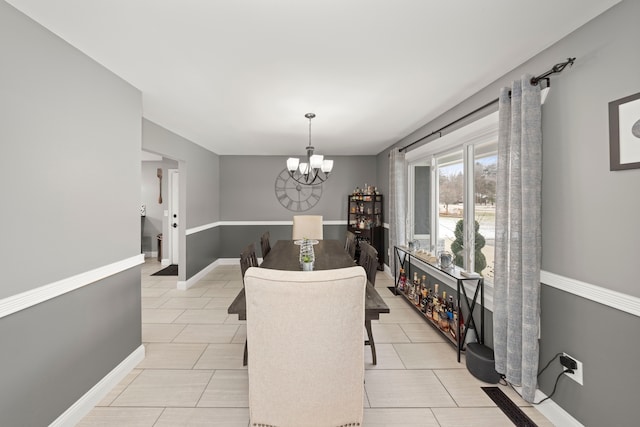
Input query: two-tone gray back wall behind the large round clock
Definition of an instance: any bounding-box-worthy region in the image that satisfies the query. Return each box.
[220,155,378,258]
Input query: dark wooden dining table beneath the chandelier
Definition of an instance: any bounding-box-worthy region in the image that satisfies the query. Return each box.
[227,239,390,365]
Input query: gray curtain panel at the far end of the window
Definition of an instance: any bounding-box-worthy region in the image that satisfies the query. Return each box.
[389,148,407,271]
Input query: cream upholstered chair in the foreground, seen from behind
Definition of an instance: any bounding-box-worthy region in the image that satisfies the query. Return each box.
[245,266,367,427]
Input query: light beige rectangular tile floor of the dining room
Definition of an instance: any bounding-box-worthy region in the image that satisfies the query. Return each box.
[78,259,552,427]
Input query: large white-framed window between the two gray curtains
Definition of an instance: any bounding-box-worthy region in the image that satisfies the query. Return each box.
[407,113,498,284]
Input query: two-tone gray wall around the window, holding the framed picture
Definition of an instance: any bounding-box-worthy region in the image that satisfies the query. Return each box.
[378,0,640,426]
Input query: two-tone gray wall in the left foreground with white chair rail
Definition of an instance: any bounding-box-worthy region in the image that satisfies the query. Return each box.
[0,2,142,426]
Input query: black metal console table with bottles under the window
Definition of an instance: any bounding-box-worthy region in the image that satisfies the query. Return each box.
[393,246,484,363]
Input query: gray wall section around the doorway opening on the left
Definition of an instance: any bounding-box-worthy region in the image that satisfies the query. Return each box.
[142,119,220,280]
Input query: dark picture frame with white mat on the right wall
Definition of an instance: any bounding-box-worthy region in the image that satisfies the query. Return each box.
[609,93,640,171]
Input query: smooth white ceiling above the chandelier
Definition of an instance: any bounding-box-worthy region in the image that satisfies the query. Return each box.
[7,0,619,155]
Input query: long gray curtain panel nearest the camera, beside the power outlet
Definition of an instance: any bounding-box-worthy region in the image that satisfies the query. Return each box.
[493,76,542,402]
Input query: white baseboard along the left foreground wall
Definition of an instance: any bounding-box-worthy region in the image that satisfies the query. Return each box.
[49,345,145,427]
